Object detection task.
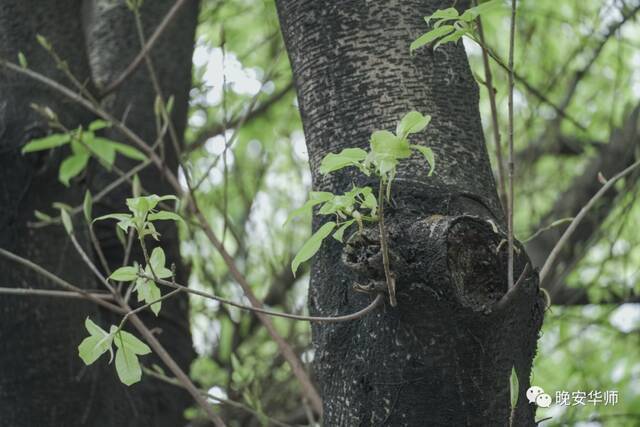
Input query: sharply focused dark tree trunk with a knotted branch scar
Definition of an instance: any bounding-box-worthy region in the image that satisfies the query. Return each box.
[277,0,543,426]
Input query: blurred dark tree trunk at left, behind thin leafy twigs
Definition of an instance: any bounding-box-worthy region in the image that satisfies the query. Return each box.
[0,0,197,427]
